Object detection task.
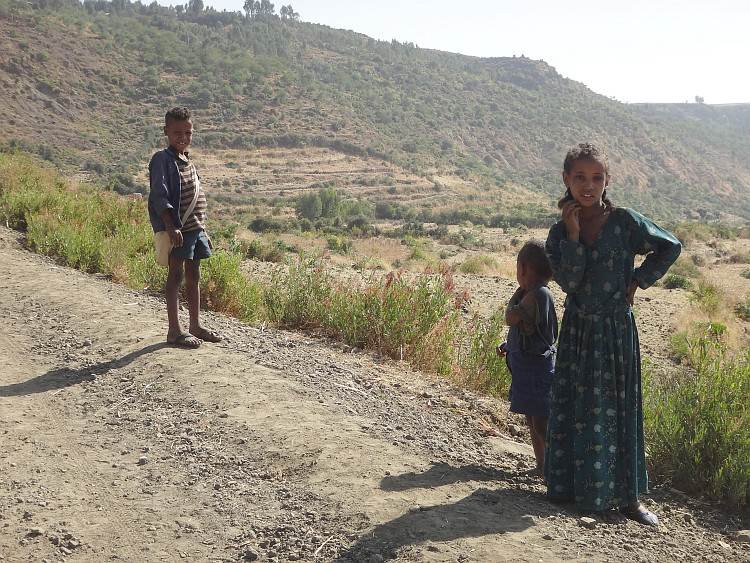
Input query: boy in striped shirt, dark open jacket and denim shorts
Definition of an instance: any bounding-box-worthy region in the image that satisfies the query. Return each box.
[148,107,222,348]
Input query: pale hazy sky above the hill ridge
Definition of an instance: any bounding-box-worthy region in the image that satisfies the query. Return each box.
[179,0,750,104]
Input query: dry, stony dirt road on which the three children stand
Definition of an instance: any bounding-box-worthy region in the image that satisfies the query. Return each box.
[0,229,750,563]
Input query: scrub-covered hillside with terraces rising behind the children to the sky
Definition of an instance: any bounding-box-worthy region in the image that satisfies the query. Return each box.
[0,0,750,222]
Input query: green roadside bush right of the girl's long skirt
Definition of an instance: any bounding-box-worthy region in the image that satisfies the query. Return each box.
[644,338,750,510]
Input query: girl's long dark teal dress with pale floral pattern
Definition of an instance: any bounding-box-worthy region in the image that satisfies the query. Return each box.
[546,208,681,510]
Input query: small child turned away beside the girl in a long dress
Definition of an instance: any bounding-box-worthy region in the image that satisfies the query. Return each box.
[497,239,557,477]
